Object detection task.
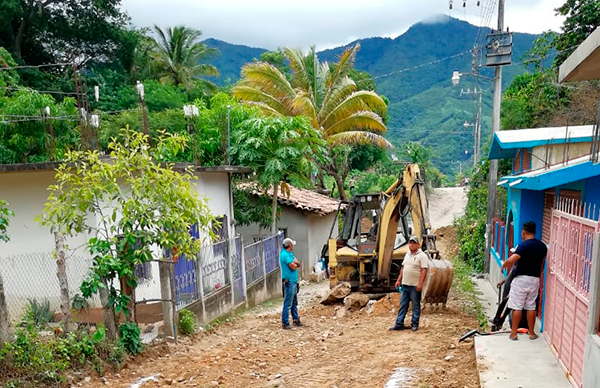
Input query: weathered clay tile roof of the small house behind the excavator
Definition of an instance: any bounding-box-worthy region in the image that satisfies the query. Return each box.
[238,182,340,216]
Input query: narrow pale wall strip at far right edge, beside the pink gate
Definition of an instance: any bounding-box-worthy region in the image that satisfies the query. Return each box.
[583,234,600,388]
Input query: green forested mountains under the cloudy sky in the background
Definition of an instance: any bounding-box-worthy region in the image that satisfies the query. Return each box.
[205,16,537,175]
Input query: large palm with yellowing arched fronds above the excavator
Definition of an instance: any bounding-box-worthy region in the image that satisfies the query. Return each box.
[232,43,391,199]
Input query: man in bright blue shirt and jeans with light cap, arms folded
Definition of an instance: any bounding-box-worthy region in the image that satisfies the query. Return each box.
[279,238,304,330]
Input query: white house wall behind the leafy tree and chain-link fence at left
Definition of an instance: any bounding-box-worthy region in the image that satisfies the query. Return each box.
[0,171,234,320]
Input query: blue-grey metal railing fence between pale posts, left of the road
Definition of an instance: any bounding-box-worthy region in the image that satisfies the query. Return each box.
[174,233,283,310]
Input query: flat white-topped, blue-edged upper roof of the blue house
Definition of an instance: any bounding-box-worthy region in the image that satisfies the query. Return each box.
[488,125,594,159]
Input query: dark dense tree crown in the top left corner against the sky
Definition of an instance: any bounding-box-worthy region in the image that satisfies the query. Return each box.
[0,0,129,64]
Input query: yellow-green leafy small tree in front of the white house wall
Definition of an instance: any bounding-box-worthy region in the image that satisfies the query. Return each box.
[40,129,214,334]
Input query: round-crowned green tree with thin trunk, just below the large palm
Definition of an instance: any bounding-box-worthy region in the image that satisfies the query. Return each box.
[231,117,324,230]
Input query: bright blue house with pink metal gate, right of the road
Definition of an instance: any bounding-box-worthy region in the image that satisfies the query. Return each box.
[489,125,600,387]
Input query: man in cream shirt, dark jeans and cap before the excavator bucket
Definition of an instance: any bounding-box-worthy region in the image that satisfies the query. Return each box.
[390,236,428,331]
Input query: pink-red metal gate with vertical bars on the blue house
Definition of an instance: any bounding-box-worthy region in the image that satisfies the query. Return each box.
[544,200,598,387]
